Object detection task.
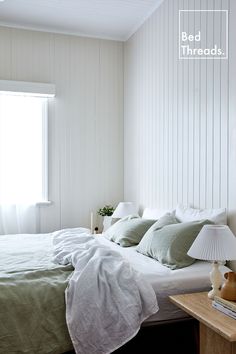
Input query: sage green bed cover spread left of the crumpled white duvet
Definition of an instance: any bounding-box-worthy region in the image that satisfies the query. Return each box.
[0,234,73,354]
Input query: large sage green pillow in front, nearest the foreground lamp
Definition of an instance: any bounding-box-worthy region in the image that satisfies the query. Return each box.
[136,220,213,269]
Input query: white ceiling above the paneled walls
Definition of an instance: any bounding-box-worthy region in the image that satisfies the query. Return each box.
[0,0,163,40]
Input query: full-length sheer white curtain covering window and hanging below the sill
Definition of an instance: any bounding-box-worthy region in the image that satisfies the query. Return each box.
[0,94,46,234]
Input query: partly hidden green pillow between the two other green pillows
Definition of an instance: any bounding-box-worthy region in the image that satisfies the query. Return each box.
[137,213,178,256]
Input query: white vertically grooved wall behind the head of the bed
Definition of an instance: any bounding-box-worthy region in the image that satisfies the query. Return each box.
[124,0,236,232]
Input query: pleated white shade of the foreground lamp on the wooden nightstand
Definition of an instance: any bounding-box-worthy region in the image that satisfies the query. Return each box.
[188,225,236,261]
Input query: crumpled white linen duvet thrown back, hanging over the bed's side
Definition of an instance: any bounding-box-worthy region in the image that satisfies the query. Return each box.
[54,228,158,354]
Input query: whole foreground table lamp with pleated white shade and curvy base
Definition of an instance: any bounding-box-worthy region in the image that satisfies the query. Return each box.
[187,225,236,299]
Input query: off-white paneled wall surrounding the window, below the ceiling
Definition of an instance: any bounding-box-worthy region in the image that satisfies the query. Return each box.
[0,27,123,232]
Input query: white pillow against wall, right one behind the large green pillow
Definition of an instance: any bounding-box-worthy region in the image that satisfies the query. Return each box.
[175,204,227,225]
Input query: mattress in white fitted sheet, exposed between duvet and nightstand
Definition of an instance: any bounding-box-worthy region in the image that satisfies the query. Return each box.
[96,234,229,323]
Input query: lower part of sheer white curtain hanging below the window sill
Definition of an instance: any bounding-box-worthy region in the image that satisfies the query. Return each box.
[0,204,38,235]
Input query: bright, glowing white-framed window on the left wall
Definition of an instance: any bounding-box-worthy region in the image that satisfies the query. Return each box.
[0,93,48,204]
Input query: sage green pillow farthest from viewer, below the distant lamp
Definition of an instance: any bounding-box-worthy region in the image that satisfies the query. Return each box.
[104,216,156,247]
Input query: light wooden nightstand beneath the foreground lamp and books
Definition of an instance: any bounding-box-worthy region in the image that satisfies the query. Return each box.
[169,292,236,354]
